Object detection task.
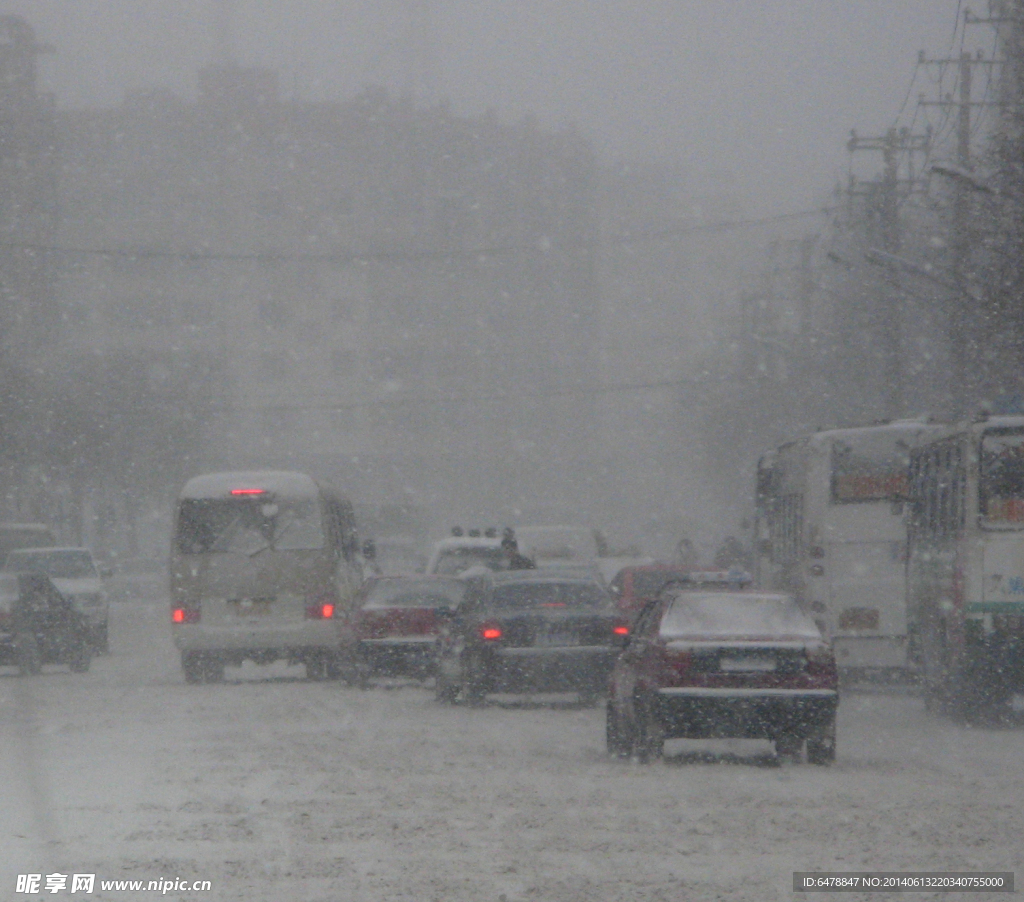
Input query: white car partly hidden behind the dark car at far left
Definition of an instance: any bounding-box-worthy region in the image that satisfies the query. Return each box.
[4,548,110,654]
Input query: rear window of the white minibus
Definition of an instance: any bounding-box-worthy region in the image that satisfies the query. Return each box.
[177,498,324,554]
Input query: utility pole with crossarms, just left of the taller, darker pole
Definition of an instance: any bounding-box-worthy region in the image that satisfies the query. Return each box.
[847,128,932,419]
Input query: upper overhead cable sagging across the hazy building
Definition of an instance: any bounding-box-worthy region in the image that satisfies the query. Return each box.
[0,207,835,263]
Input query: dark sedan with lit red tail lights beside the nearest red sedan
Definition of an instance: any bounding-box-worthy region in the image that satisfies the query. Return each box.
[436,567,628,703]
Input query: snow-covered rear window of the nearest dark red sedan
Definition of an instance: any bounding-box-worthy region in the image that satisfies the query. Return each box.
[662,592,821,639]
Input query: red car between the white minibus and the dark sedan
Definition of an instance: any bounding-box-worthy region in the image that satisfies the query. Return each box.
[355,576,466,680]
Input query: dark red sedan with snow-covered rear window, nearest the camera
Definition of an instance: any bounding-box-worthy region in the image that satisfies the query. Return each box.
[607,589,839,765]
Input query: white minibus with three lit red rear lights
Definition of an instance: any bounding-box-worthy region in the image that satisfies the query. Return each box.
[170,471,361,683]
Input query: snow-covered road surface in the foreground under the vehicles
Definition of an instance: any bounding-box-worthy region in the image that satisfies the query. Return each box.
[0,603,1024,902]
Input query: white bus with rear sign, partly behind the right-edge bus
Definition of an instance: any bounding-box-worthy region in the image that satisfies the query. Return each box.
[755,420,939,675]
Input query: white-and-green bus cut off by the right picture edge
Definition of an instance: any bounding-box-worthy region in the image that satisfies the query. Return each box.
[907,417,1024,717]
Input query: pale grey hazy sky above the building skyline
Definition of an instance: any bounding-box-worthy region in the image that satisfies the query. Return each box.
[6,0,992,213]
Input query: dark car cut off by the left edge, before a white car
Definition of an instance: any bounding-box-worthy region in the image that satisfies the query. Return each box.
[0,571,91,675]
